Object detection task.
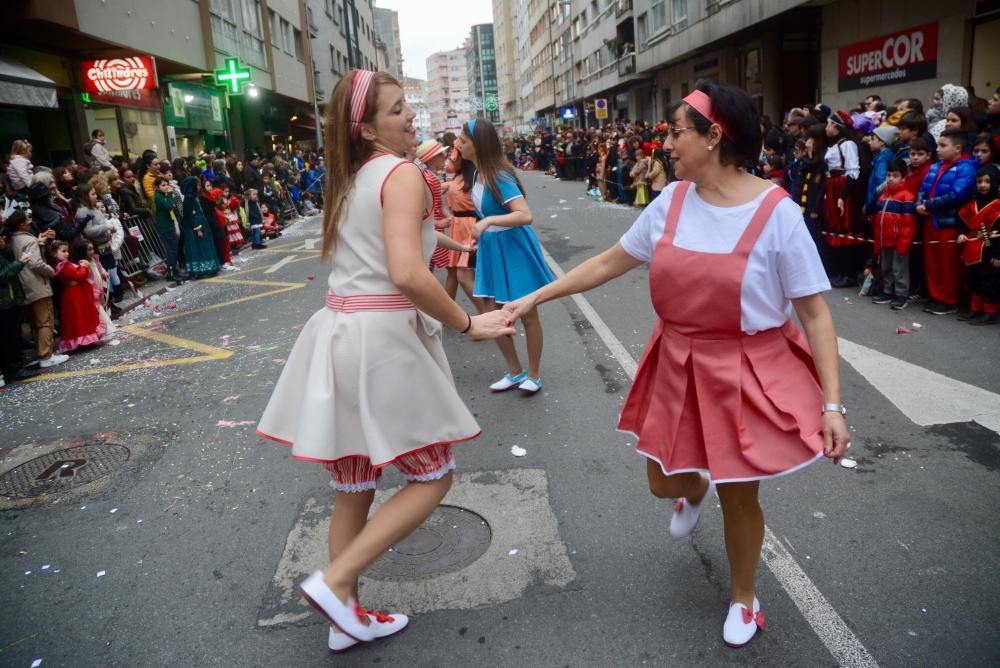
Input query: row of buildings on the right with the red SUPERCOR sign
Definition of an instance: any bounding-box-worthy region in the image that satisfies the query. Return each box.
[512,0,1000,132]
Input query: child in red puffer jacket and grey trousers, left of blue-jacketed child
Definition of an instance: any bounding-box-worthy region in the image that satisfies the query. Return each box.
[872,158,917,311]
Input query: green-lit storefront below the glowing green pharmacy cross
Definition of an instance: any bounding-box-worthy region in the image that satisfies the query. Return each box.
[163,81,231,157]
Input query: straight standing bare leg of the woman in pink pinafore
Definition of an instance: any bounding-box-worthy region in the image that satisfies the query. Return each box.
[717,481,764,610]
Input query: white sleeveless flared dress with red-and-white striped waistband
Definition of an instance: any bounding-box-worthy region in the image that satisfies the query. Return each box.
[257,155,481,467]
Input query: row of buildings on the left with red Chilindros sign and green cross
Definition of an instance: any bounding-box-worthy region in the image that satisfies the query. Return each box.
[0,0,375,165]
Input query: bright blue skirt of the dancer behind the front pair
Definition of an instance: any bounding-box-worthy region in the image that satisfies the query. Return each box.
[473,225,555,304]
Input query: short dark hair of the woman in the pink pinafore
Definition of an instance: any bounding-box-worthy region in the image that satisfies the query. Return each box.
[685,80,761,169]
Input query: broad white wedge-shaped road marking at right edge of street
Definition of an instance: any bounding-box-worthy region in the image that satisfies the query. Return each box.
[838,339,1000,433]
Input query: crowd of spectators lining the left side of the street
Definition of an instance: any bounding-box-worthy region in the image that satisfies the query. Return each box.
[0,136,326,387]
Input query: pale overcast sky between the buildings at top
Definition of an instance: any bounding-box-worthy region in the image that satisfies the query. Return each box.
[375,0,493,79]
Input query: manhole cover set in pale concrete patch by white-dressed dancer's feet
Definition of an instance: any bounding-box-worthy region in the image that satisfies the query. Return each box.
[365,506,493,580]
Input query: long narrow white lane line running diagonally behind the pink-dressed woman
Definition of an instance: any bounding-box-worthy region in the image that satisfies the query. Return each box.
[542,247,878,668]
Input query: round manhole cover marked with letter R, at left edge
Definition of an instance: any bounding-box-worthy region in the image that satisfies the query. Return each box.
[0,443,130,498]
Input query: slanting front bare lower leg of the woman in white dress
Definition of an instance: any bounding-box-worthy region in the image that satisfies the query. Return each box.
[323,473,452,601]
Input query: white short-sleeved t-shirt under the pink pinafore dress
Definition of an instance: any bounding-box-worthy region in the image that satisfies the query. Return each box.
[620,183,830,334]
